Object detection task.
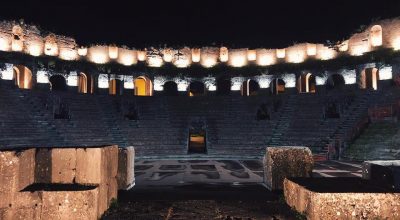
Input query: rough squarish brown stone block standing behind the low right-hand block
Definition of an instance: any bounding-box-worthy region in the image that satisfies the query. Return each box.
[263,147,314,190]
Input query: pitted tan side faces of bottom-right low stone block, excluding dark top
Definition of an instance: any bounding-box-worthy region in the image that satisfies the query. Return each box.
[284,179,400,220]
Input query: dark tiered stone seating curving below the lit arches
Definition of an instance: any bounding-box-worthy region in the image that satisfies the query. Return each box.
[0,83,399,158]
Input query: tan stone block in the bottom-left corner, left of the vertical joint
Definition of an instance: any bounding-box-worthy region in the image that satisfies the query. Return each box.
[0,192,42,220]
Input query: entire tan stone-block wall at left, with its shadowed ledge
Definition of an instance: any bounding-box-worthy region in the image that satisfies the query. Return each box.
[0,146,134,219]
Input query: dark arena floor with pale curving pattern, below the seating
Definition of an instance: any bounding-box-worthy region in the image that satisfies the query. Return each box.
[135,160,361,187]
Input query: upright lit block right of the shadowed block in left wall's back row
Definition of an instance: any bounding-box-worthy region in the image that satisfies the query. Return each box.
[51,148,76,184]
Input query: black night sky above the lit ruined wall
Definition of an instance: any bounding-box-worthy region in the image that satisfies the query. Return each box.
[0,0,400,48]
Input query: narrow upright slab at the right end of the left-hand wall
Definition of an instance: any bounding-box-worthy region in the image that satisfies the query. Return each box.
[117,147,135,190]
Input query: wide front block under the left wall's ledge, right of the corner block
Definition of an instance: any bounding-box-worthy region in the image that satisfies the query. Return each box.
[40,187,99,220]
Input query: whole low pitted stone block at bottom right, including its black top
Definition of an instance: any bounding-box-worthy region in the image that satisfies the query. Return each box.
[284,178,400,220]
